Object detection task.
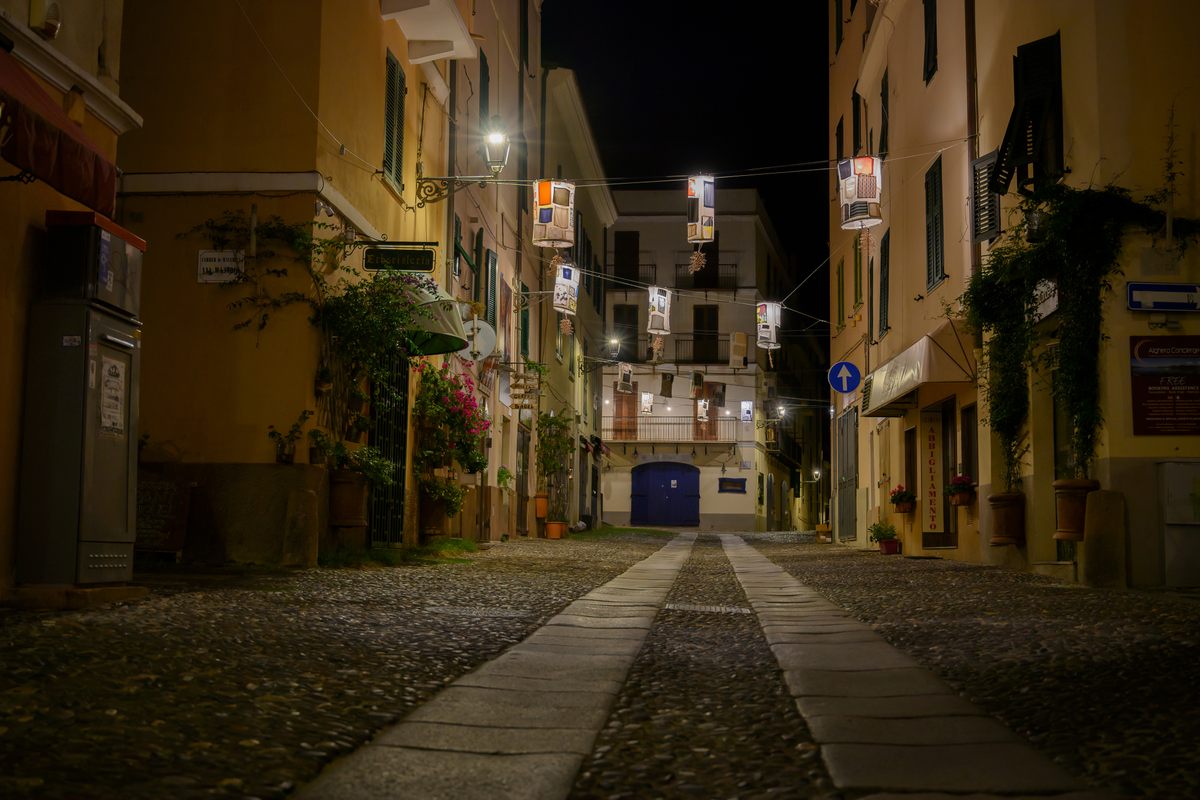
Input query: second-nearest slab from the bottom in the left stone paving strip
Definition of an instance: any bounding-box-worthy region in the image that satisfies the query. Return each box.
[376,721,596,756]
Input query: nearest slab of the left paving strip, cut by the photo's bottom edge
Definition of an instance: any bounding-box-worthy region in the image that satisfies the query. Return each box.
[300,745,583,800]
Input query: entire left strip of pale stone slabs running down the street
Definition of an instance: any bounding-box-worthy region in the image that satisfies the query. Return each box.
[298,534,696,800]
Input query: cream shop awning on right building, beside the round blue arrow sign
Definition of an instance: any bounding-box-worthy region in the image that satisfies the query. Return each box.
[863,323,976,416]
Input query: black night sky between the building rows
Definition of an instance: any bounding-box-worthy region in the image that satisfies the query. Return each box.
[542,0,828,318]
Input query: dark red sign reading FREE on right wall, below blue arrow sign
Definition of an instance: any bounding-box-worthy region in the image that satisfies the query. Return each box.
[1129,336,1200,437]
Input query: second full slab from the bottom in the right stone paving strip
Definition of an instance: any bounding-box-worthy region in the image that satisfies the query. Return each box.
[805,716,1021,745]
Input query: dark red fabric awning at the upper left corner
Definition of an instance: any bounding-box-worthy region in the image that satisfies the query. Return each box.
[0,50,116,217]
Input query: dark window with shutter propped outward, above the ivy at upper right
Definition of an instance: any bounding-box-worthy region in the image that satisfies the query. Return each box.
[991,34,1064,194]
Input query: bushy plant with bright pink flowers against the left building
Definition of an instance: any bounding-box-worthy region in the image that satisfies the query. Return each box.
[413,362,491,516]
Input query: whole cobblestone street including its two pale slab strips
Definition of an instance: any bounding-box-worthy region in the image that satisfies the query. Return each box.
[0,534,1200,800]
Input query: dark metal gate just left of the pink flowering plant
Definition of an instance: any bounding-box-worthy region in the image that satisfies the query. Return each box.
[368,355,408,547]
